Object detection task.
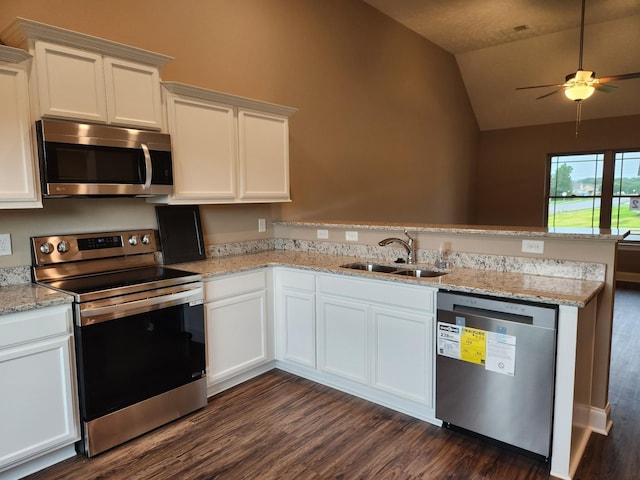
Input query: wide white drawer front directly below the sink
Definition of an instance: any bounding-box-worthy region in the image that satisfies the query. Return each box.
[318,275,436,313]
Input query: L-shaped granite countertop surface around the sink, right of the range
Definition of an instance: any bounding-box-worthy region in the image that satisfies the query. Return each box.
[172,250,604,307]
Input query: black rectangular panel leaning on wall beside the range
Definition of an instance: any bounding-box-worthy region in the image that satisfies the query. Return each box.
[156,205,206,264]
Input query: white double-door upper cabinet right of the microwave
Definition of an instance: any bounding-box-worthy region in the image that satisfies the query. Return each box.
[156,82,296,204]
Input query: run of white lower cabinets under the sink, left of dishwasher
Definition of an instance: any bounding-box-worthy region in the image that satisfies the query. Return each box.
[275,268,438,423]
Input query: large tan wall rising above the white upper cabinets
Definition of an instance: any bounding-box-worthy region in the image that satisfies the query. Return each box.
[0,0,479,232]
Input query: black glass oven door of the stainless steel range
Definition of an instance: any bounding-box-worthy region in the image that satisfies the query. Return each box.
[75,282,205,422]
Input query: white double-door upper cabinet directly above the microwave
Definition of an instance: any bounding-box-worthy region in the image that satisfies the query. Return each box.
[3,18,171,130]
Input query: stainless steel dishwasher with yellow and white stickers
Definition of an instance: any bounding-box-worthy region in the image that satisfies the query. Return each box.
[436,291,558,460]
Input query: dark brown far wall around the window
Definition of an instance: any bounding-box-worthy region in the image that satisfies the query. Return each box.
[474,114,640,226]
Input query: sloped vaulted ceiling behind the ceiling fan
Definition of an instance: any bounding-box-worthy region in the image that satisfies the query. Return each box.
[364,0,640,130]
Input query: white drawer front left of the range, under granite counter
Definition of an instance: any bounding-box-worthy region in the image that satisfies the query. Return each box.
[0,305,72,348]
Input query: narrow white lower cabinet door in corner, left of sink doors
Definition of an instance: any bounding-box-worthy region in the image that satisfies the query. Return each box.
[277,289,316,368]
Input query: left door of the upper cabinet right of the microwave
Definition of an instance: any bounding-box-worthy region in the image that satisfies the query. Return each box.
[167,95,237,203]
